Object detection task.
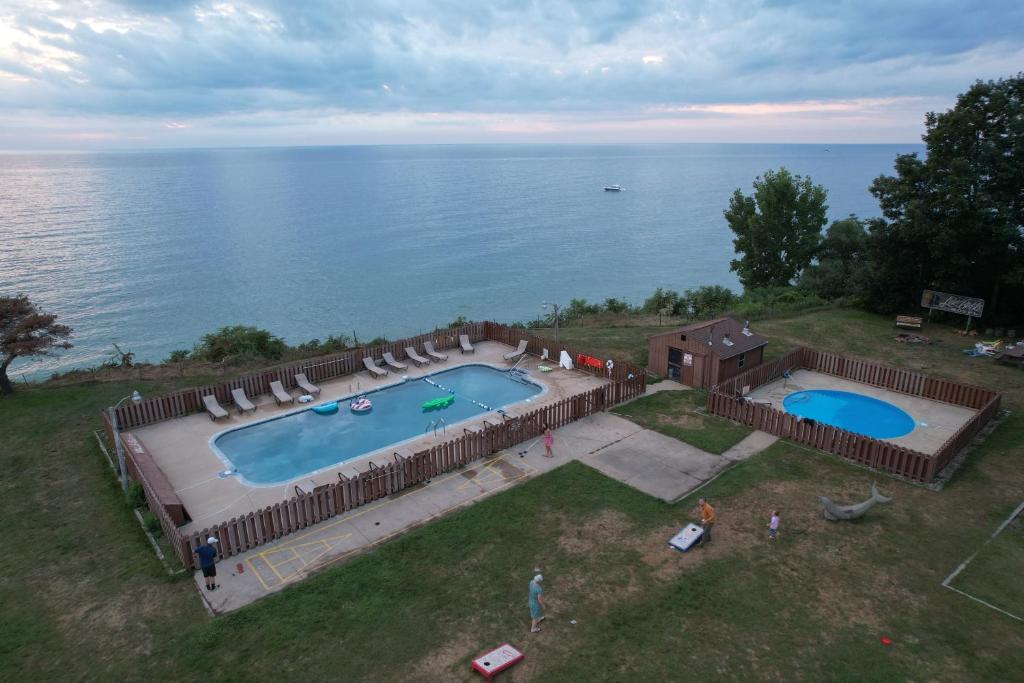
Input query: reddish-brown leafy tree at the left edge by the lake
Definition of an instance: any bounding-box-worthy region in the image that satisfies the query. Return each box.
[0,294,72,394]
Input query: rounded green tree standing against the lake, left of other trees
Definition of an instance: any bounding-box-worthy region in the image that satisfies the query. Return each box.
[725,168,828,289]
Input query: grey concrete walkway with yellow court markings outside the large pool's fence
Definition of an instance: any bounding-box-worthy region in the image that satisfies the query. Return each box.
[196,413,776,613]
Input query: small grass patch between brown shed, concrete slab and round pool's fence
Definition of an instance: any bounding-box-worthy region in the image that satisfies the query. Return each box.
[611,390,754,454]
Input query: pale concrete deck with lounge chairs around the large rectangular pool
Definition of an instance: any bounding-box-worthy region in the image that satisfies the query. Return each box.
[131,342,607,533]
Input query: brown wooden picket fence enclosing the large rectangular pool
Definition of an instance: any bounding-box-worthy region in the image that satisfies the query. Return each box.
[103,323,646,569]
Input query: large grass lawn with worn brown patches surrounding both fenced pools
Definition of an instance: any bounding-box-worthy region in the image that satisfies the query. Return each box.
[0,310,1024,681]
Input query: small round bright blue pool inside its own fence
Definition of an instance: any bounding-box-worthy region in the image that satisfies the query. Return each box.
[782,389,916,438]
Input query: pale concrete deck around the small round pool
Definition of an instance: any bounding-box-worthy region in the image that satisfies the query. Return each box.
[746,370,977,455]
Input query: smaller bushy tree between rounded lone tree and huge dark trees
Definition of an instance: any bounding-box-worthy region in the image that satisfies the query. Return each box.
[800,215,867,299]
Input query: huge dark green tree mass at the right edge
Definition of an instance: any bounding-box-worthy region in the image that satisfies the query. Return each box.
[866,74,1024,319]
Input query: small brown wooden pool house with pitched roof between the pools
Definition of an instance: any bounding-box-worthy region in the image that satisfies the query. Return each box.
[647,317,768,389]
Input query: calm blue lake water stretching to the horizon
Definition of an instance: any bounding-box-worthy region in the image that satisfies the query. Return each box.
[0,144,924,378]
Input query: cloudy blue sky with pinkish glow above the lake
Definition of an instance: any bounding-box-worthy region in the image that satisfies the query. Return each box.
[0,0,1024,151]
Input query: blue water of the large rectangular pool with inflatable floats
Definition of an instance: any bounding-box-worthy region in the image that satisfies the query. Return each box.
[211,365,543,486]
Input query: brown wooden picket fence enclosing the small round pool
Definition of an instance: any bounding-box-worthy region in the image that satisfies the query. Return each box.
[708,347,1001,482]
